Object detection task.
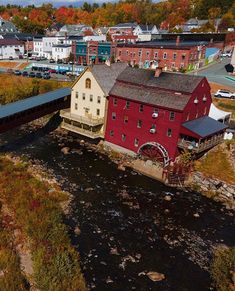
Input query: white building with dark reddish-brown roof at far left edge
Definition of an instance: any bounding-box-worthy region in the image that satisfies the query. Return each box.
[0,39,24,60]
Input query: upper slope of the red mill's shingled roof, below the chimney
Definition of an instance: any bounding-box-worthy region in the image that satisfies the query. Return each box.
[117,67,204,93]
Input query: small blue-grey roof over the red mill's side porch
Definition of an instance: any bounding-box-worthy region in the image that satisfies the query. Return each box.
[182,116,227,138]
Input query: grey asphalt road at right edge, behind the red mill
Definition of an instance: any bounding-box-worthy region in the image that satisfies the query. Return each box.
[193,58,235,89]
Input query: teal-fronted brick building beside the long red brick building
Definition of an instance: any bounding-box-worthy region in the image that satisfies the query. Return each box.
[72,41,115,65]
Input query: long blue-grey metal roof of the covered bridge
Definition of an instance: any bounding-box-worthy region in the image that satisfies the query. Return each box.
[0,88,71,118]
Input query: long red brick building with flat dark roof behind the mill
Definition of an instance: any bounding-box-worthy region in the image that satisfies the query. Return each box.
[116,40,207,71]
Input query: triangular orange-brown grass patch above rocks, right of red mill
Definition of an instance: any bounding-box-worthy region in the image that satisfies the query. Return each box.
[195,146,235,184]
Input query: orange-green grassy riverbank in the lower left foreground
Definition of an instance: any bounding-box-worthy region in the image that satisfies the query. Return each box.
[0,156,86,291]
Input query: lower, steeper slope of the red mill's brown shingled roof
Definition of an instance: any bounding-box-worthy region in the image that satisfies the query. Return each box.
[110,82,190,111]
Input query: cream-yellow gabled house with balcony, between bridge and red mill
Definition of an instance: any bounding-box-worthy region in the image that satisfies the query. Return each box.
[60,63,127,139]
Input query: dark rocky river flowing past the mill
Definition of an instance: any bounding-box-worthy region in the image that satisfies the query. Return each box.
[0,119,235,291]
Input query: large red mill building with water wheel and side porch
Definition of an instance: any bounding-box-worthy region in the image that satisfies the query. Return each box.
[105,67,226,165]
